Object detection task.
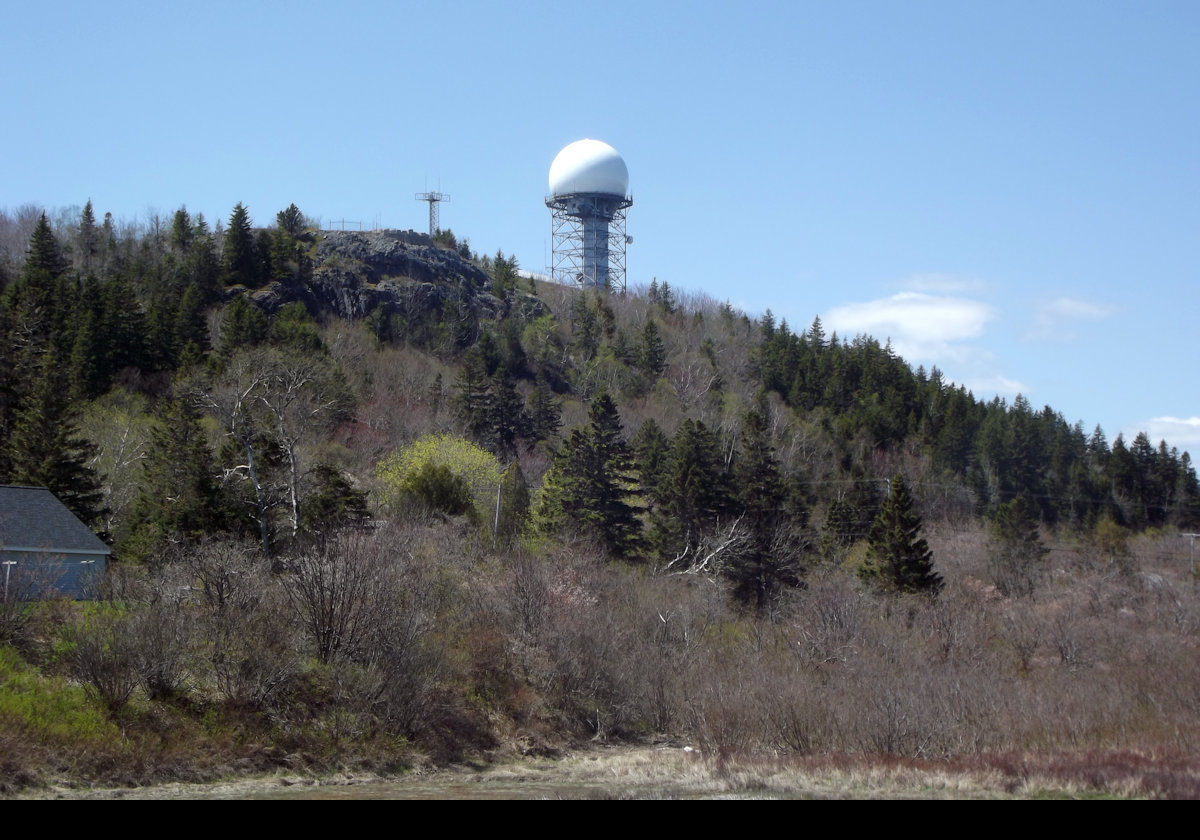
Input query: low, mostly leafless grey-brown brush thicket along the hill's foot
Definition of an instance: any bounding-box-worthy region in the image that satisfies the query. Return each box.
[0,521,1200,792]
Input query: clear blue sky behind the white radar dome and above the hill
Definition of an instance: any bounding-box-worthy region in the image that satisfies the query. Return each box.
[0,0,1200,452]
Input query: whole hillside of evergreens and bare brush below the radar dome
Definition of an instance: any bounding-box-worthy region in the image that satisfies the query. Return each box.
[0,202,1200,792]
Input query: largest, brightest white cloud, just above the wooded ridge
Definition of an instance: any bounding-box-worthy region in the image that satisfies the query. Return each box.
[822,292,996,364]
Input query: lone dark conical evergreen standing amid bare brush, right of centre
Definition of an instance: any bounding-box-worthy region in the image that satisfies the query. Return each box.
[858,475,942,595]
